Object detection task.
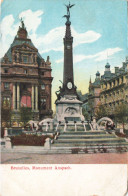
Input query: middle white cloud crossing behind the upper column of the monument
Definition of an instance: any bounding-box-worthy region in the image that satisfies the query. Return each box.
[37,26,101,53]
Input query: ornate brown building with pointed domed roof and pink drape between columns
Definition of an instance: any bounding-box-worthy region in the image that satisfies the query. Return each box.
[1,21,53,123]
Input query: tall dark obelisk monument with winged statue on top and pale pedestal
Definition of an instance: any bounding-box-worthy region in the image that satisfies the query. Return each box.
[55,3,84,122]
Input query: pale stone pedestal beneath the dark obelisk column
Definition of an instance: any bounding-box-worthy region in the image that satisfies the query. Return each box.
[55,95,85,123]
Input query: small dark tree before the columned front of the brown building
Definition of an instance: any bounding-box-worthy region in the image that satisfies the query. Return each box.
[20,107,33,126]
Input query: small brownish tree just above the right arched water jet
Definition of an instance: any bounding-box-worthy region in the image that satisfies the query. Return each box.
[95,104,108,119]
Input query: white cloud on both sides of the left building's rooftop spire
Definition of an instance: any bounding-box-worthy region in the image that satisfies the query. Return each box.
[0,9,43,57]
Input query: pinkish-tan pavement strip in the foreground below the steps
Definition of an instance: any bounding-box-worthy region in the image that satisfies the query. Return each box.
[1,152,128,164]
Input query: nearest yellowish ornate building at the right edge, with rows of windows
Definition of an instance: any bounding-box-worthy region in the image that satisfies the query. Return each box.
[100,58,128,117]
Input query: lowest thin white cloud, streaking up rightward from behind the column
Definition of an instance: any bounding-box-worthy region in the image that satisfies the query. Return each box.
[56,47,122,63]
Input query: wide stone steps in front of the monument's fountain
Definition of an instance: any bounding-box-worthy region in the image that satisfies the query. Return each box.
[52,130,128,149]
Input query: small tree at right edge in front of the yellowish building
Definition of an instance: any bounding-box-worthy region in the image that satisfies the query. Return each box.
[114,103,128,129]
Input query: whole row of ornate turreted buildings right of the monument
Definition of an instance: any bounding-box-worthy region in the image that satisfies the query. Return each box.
[81,58,128,118]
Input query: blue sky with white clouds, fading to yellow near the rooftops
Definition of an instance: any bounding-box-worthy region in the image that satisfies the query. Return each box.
[0,0,127,109]
